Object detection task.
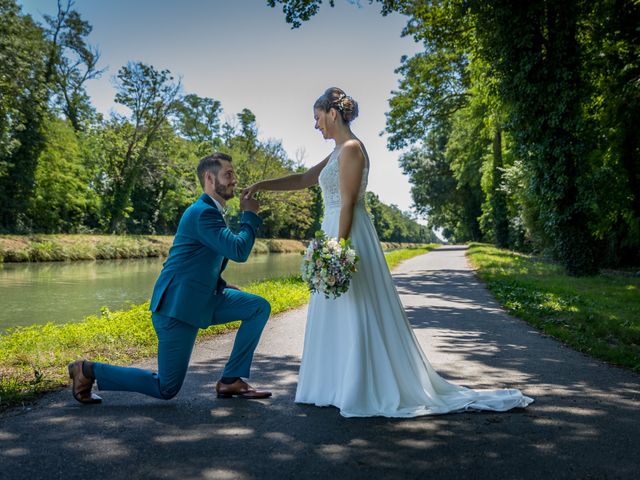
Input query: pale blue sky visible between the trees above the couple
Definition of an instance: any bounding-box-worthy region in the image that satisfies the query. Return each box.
[19,0,424,217]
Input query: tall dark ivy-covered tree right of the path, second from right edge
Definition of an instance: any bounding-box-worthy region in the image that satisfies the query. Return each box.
[472,1,598,275]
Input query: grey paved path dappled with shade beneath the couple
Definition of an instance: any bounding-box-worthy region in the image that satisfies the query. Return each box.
[0,247,640,480]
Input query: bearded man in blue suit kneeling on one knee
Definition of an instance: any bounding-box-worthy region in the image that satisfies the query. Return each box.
[69,153,271,403]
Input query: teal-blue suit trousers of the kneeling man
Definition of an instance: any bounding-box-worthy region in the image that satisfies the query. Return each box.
[93,289,271,400]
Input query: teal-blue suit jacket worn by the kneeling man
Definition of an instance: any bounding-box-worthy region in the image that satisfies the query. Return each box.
[150,193,262,328]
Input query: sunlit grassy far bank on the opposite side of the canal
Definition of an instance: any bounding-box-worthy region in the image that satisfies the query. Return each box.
[0,234,430,263]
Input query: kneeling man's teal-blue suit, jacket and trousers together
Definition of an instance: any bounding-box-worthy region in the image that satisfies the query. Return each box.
[94,193,271,399]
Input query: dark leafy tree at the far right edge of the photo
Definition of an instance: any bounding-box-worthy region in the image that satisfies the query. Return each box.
[581,0,640,266]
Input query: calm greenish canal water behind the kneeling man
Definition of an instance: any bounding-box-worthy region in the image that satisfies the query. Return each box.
[0,253,302,331]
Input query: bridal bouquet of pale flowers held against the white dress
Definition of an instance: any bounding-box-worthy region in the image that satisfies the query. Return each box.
[301,230,358,298]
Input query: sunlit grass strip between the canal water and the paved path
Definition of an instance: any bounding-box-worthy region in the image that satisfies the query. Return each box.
[0,245,436,408]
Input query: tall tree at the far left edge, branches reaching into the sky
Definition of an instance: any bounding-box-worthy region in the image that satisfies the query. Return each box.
[0,0,99,231]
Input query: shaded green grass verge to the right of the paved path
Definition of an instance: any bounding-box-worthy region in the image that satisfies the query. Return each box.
[468,244,640,372]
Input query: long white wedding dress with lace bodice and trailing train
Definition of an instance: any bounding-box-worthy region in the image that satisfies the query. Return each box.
[295,144,533,417]
